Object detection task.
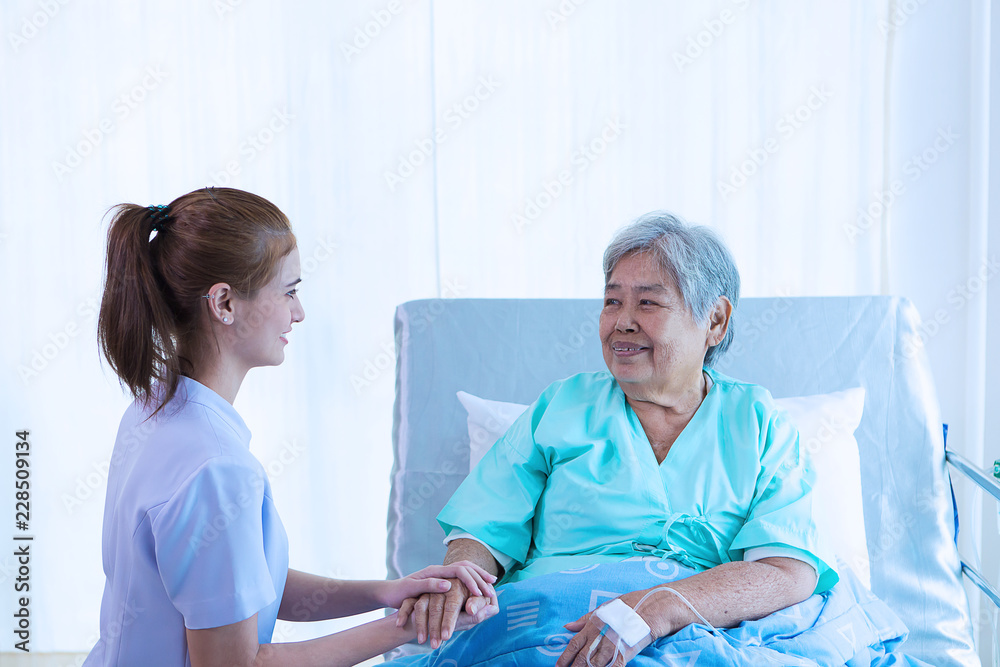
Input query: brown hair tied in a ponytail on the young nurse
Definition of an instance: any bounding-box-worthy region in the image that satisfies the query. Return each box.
[97,188,296,414]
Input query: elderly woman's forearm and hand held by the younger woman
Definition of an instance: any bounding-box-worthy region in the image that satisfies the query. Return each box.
[399,539,500,648]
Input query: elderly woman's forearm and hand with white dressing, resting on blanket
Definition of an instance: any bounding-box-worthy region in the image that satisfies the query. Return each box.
[556,557,816,667]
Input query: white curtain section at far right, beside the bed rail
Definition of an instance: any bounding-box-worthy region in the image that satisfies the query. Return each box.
[877,0,1000,664]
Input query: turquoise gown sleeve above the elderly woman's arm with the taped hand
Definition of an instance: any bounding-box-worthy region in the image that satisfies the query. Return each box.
[729,401,840,593]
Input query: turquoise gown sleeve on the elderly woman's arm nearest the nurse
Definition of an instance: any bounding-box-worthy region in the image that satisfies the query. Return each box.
[437,388,551,564]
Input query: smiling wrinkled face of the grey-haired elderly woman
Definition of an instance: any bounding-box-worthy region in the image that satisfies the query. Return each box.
[600,253,709,402]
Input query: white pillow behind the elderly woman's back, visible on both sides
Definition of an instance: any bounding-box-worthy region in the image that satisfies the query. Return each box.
[458,387,871,588]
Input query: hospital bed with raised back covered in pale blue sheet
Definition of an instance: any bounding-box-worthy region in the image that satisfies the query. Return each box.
[387,297,1000,667]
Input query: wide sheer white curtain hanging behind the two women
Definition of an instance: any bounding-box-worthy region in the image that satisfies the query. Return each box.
[0,0,982,651]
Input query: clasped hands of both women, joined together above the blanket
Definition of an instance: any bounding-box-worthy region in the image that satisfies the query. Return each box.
[388,560,500,648]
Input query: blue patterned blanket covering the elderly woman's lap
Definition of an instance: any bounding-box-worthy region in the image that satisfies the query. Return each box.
[385,560,926,667]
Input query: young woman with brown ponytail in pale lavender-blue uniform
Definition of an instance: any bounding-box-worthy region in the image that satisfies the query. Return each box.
[84,188,497,667]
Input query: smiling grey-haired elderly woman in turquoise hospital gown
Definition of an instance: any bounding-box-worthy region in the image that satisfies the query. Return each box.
[404,213,838,667]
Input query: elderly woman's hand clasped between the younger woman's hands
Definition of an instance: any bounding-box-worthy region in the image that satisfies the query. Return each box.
[396,579,500,648]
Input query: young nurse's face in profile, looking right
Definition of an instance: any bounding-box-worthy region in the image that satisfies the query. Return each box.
[236,248,305,368]
